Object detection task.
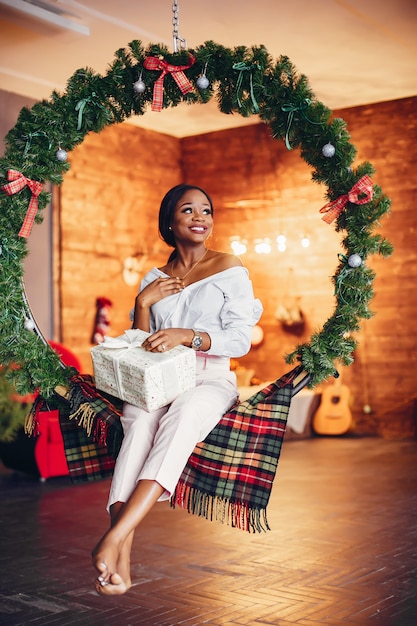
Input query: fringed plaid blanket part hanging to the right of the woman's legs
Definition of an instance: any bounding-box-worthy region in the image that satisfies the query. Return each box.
[171,366,301,532]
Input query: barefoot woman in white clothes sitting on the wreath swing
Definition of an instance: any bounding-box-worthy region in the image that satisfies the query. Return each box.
[93,184,262,595]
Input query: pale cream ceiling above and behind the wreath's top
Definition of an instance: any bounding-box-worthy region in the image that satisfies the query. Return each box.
[0,0,417,137]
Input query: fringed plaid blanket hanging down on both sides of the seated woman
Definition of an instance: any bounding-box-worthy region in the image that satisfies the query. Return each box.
[57,367,300,532]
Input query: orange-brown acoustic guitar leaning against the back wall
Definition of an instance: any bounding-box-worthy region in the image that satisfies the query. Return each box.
[312,376,352,435]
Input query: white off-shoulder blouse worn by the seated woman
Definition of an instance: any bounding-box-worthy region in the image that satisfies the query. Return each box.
[139,266,263,358]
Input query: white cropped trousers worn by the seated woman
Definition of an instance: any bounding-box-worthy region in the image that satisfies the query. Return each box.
[107,353,238,509]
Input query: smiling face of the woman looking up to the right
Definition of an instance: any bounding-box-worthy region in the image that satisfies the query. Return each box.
[171,189,213,244]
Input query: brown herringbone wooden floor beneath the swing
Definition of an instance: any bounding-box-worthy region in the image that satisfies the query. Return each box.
[0,438,417,626]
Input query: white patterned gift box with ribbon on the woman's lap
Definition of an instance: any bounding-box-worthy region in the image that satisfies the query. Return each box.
[91,330,196,411]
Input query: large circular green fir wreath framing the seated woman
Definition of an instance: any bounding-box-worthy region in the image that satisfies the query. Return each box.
[0,41,392,398]
